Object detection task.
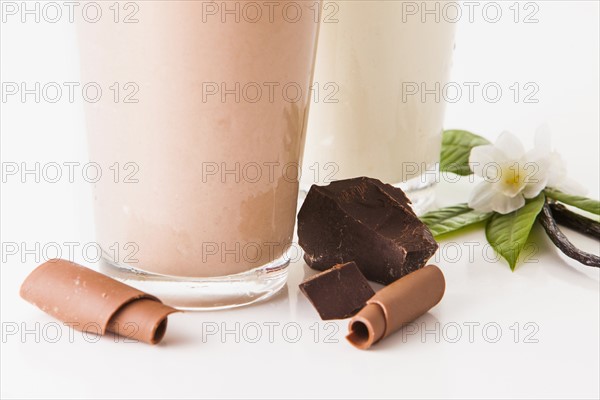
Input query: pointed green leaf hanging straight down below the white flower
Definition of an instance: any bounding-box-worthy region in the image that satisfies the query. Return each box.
[485,193,546,271]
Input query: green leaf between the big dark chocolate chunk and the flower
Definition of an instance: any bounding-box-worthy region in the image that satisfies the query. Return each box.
[421,204,493,236]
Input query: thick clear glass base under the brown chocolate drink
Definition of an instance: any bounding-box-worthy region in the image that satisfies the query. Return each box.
[100,255,289,310]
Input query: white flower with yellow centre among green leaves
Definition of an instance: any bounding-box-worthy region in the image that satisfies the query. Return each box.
[469,129,582,214]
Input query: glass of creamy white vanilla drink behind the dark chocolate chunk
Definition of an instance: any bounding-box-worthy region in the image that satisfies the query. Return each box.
[302,0,458,211]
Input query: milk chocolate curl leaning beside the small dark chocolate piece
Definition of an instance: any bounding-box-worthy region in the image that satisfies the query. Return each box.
[346,265,446,350]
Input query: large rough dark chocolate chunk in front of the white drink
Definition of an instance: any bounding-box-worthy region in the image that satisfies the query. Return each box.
[298,177,438,285]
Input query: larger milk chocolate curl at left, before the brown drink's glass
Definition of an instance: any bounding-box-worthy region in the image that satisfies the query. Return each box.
[21,259,177,344]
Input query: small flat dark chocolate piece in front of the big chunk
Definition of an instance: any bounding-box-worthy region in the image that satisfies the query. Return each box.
[300,262,375,320]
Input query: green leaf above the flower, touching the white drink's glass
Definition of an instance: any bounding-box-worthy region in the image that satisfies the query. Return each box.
[440,130,490,176]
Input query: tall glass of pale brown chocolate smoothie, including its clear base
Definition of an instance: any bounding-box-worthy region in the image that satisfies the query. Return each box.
[78,0,319,309]
